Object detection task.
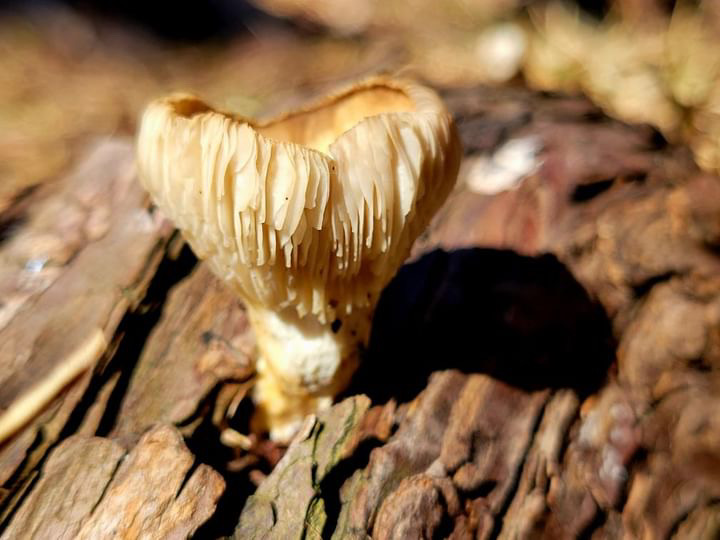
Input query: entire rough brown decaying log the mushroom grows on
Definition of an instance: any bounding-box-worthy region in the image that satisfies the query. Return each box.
[0,88,720,539]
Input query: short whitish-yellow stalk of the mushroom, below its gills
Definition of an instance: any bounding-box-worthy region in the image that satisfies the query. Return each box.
[248,308,371,441]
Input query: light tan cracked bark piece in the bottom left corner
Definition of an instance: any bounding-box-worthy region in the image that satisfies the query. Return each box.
[3,425,225,539]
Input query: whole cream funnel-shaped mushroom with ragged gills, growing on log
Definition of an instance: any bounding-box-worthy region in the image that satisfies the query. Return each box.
[138,76,462,440]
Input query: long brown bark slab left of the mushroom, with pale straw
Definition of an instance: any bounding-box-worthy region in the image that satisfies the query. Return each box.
[0,140,172,524]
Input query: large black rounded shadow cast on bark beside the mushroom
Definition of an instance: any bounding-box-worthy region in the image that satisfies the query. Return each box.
[347,248,615,403]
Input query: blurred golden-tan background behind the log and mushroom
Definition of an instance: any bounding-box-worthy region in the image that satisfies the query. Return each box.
[0,0,720,211]
